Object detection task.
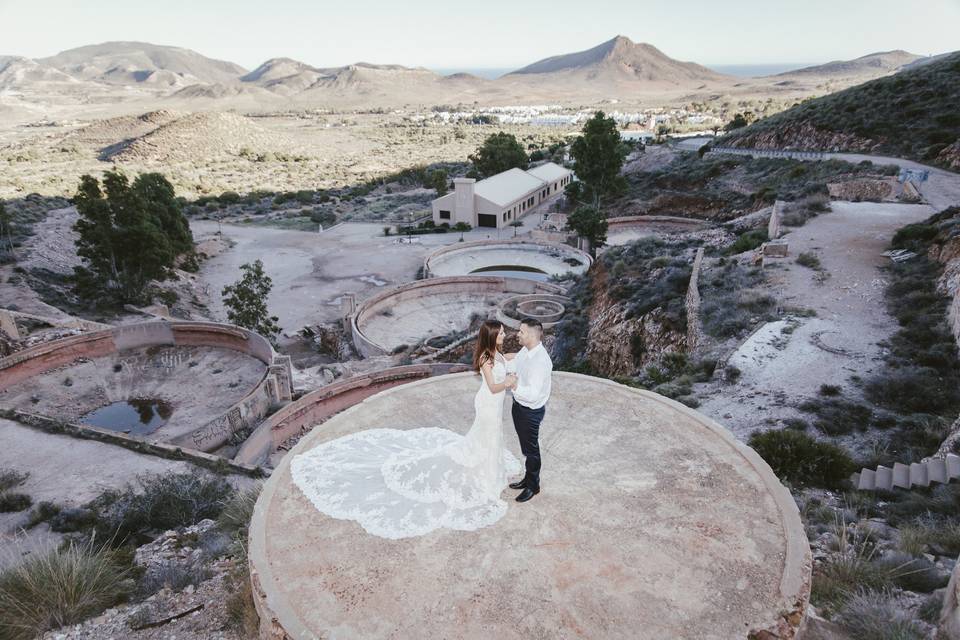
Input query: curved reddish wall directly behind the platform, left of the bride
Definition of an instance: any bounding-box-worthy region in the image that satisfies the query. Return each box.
[233,363,468,465]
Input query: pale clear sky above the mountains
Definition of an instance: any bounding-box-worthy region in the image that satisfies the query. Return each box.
[0,0,960,69]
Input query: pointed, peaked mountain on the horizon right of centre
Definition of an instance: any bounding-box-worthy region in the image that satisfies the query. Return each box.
[502,36,733,87]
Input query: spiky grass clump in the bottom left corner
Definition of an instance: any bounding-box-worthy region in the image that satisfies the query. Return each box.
[0,542,133,640]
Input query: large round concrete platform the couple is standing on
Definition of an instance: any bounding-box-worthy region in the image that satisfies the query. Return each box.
[250,373,810,639]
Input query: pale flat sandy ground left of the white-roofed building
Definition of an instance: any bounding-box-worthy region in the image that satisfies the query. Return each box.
[191,216,540,335]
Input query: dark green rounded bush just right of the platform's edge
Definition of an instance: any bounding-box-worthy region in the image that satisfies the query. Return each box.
[748,429,856,488]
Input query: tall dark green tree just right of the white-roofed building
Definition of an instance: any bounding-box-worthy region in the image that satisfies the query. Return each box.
[570,111,626,209]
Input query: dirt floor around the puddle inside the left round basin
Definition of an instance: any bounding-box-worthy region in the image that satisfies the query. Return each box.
[0,347,265,441]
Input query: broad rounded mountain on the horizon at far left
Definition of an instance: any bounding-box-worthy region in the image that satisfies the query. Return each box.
[37,42,247,87]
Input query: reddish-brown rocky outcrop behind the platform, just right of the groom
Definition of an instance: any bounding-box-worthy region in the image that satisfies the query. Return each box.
[585,261,686,377]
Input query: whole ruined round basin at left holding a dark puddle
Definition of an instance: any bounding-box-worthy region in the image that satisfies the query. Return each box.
[0,321,292,452]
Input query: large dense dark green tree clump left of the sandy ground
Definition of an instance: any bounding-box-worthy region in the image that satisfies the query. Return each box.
[73,171,193,303]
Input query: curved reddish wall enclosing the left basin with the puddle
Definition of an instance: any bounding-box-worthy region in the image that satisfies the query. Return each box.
[0,321,293,451]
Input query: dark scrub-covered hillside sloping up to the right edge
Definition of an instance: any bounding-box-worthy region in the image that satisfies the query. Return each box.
[717,53,960,170]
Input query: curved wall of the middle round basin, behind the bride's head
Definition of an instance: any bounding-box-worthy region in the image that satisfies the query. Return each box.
[350,276,565,358]
